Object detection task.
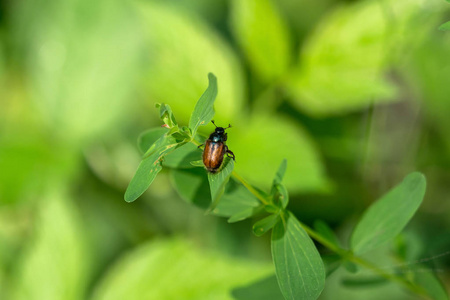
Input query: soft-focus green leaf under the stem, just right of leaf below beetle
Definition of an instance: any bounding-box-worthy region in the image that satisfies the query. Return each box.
[213,180,260,218]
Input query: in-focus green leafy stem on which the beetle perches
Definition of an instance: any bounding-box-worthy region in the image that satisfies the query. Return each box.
[125,74,439,299]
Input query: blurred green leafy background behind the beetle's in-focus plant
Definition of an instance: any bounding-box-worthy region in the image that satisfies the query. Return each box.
[0,0,450,300]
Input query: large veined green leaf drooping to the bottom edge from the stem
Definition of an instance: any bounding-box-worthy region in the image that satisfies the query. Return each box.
[272,212,325,300]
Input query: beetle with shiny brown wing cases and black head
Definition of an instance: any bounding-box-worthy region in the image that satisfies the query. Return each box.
[199,120,236,173]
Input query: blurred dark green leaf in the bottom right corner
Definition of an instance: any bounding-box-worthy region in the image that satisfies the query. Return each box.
[413,266,449,300]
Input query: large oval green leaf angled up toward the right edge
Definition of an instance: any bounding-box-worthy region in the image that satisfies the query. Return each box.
[351,172,426,254]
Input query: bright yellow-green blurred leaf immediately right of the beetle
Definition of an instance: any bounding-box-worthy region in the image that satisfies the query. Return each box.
[227,114,328,193]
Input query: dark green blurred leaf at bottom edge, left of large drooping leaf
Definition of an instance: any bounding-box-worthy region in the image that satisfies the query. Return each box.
[231,275,285,300]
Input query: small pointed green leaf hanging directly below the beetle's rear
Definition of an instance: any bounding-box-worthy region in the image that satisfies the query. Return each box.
[208,157,234,212]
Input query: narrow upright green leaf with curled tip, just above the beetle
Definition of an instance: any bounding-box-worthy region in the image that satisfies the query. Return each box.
[189,73,217,136]
